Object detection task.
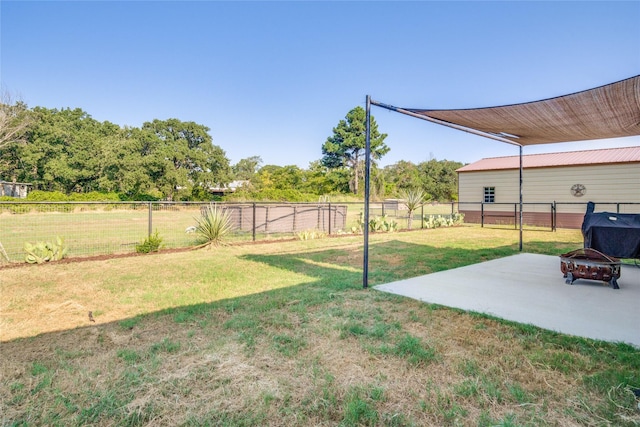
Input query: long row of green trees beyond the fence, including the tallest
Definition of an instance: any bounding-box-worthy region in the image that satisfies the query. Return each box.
[0,99,463,201]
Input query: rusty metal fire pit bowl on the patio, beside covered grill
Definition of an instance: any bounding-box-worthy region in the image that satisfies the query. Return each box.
[560,248,620,289]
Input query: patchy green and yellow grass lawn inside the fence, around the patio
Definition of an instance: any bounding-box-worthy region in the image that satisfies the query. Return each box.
[0,226,640,426]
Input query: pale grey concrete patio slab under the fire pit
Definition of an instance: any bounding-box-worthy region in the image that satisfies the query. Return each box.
[375,254,640,348]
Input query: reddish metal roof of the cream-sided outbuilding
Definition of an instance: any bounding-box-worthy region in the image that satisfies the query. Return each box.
[457,146,640,172]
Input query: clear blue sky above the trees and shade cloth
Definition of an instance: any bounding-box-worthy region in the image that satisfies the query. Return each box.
[0,0,640,168]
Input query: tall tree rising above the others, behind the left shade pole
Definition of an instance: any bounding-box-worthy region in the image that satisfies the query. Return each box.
[321,106,389,194]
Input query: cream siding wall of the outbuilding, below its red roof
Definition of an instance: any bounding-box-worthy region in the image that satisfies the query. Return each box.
[458,163,640,212]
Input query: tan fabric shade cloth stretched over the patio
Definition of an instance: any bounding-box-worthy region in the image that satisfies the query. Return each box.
[405,75,640,145]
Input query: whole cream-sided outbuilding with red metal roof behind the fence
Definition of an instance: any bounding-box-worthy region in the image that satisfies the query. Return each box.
[457,146,640,228]
